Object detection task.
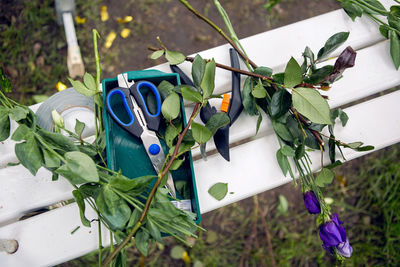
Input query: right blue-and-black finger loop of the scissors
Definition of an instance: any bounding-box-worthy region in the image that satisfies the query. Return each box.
[130,81,161,131]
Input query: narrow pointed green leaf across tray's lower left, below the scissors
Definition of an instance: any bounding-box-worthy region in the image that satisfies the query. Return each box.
[109,174,157,194]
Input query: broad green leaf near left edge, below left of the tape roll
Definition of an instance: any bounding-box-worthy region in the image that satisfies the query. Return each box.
[15,135,44,175]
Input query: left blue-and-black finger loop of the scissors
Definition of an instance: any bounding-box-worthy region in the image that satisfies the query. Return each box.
[106,87,143,137]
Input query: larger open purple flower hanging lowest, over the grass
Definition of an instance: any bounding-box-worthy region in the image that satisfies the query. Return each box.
[319,213,353,258]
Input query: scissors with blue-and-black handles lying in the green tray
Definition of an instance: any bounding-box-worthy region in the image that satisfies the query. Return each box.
[106,73,176,198]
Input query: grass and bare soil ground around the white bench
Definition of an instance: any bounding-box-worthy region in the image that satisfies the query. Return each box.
[0,0,400,267]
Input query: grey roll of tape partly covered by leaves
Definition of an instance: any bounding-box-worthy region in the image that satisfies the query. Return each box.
[36,87,96,139]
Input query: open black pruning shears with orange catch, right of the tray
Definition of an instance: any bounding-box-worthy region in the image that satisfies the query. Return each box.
[170,48,243,161]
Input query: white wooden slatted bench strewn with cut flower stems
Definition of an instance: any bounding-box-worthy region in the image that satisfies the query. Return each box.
[0,0,400,266]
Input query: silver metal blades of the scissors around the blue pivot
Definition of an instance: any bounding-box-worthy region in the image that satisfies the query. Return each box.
[140,130,176,198]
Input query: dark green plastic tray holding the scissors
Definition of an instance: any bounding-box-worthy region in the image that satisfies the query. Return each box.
[102,70,201,224]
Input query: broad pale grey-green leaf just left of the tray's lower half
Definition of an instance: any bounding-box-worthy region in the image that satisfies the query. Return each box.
[56,151,99,184]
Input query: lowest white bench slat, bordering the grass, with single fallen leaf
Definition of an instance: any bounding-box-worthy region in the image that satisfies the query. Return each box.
[0,91,400,267]
